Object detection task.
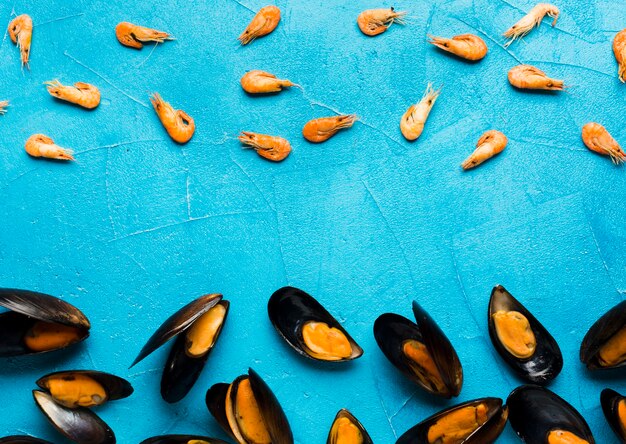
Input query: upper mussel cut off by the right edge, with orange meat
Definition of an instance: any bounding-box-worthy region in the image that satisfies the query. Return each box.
[580,301,626,370]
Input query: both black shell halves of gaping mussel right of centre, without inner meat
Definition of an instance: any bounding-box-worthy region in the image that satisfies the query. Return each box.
[374,301,463,398]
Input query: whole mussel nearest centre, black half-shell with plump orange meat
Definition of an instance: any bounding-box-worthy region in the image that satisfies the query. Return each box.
[267,287,363,361]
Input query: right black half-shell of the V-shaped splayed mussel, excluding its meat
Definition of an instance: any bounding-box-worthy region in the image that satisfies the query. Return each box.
[161,300,230,403]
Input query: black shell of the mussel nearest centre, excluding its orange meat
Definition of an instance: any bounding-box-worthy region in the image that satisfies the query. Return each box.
[267,287,363,362]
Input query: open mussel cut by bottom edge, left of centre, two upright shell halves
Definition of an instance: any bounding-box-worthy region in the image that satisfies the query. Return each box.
[206,369,294,444]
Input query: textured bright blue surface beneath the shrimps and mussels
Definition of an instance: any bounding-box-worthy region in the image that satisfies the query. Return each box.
[0,0,626,444]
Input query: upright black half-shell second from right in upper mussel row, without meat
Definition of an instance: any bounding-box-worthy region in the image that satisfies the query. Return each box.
[488,285,563,384]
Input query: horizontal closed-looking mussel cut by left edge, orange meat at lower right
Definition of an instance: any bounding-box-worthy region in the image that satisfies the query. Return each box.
[0,288,90,357]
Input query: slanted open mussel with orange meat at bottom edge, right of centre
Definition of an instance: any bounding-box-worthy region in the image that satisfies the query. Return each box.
[396,398,508,444]
